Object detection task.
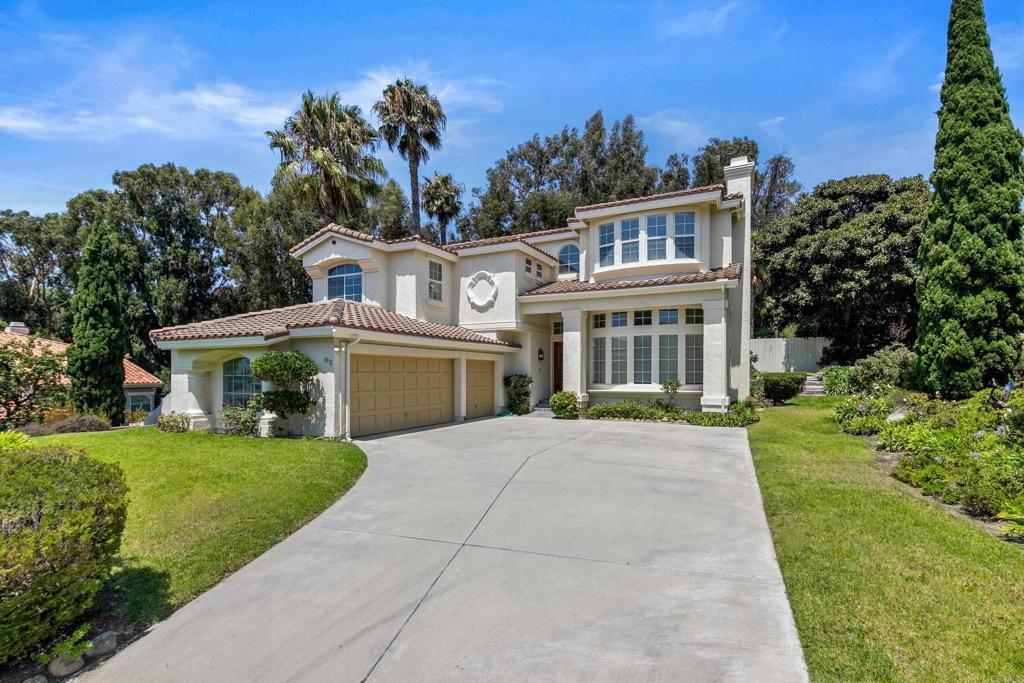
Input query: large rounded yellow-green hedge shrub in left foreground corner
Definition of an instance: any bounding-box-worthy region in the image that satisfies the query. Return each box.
[0,446,128,664]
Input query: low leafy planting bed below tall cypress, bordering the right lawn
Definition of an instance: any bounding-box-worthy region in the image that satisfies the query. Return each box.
[836,389,1024,533]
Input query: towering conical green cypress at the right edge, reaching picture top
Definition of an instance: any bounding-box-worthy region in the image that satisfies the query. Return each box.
[916,0,1024,398]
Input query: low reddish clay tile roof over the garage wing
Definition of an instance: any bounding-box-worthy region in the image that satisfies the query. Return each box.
[150,299,511,346]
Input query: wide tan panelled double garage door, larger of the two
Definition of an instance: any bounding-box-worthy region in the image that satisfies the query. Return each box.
[350,355,454,436]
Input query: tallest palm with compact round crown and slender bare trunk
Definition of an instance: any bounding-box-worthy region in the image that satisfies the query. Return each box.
[374,78,447,234]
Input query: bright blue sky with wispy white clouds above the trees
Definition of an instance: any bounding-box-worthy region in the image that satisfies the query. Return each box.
[0,0,1024,213]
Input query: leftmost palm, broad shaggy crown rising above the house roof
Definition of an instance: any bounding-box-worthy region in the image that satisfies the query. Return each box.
[266,90,385,220]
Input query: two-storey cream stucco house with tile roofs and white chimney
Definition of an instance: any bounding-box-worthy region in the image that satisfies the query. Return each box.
[151,158,754,437]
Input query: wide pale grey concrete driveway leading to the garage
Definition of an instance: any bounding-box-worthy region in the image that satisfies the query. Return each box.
[84,418,807,683]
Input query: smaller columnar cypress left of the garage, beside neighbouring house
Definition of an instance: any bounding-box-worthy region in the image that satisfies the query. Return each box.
[68,220,128,425]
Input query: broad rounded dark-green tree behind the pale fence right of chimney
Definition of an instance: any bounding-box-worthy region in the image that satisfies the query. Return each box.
[754,175,929,361]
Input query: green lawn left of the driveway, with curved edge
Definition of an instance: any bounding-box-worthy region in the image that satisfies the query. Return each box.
[33,427,367,624]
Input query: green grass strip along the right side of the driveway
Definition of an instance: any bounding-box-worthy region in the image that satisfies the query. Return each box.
[750,398,1024,682]
